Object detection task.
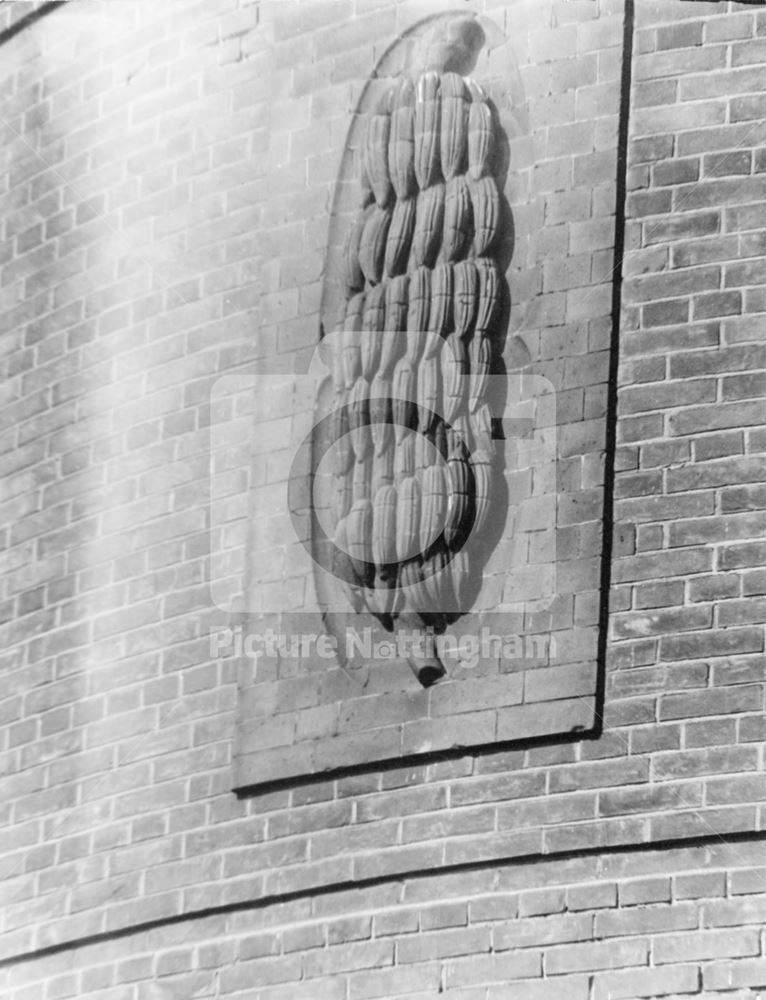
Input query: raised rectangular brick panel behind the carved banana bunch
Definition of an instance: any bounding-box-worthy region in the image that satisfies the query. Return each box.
[236,0,623,787]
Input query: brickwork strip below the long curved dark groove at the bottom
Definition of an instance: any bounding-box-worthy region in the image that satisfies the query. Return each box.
[0,843,766,1000]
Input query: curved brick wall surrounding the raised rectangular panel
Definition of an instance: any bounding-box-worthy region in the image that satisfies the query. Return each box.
[0,0,766,1000]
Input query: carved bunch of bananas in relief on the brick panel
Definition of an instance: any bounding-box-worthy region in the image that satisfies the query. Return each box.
[318,18,505,684]
